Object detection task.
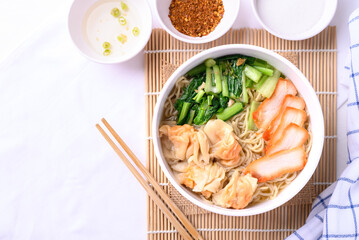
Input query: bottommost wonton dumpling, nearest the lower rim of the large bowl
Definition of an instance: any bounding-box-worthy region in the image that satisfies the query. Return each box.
[212,170,257,209]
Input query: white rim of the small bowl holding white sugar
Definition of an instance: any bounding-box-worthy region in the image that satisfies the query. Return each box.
[251,0,338,41]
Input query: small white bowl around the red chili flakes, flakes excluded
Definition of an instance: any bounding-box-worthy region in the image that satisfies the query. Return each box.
[155,0,240,43]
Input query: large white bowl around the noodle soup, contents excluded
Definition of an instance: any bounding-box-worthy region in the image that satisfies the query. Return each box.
[152,44,324,216]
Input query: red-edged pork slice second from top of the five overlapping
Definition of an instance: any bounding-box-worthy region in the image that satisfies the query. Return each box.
[263,95,305,141]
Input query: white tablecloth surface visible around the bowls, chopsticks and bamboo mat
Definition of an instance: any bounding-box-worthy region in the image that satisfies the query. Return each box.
[0,0,359,240]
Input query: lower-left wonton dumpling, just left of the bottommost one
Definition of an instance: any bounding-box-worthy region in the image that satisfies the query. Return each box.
[171,162,226,198]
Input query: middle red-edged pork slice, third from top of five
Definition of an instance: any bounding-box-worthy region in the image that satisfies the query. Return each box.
[266,107,307,151]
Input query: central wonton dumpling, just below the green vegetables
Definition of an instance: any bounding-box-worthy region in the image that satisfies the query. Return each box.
[203,119,242,167]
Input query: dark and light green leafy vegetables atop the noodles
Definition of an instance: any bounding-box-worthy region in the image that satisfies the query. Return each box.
[175,54,281,126]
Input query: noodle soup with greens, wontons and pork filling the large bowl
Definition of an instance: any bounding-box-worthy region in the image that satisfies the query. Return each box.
[159,55,312,209]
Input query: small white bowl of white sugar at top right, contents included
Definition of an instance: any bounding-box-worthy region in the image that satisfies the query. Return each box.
[251,0,338,40]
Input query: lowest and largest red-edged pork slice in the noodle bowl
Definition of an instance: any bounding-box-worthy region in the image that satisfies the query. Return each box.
[243,147,307,182]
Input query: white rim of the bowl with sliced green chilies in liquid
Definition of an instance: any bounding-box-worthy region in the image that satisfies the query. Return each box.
[66,0,153,64]
